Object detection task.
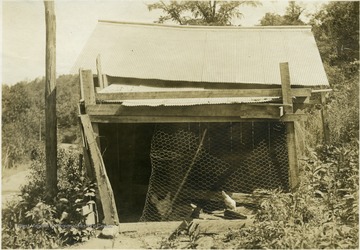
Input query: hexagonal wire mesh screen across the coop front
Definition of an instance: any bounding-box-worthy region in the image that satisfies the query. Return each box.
[140,122,289,221]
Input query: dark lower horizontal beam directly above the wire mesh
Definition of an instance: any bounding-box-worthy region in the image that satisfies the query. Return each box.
[87,104,304,123]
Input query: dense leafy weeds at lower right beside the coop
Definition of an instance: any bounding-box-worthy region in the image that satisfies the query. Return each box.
[224,142,359,249]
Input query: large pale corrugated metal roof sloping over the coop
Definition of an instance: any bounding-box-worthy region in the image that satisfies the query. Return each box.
[73,21,328,86]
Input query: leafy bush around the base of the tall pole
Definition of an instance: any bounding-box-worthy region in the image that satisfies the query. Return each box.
[2,150,96,248]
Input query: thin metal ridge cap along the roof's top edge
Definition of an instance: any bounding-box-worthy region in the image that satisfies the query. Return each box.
[98,19,312,30]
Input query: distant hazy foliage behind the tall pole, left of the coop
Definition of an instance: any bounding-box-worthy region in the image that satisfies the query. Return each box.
[2,75,80,167]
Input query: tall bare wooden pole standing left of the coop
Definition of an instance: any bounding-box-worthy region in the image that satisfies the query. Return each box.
[44,0,57,199]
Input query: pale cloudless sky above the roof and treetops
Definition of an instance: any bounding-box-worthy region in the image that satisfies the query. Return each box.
[0,0,330,85]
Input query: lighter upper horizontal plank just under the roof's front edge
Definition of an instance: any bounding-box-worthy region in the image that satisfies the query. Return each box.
[96,88,311,101]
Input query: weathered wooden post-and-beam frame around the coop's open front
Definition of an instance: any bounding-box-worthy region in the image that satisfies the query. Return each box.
[79,62,324,224]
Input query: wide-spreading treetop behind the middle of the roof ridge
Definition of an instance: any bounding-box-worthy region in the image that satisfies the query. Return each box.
[148,1,261,26]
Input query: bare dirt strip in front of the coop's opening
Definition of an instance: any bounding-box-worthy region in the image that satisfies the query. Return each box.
[71,219,252,249]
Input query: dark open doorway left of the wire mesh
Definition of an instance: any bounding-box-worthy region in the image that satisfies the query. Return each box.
[99,123,155,222]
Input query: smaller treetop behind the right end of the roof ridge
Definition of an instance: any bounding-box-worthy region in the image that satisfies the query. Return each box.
[260,1,305,26]
